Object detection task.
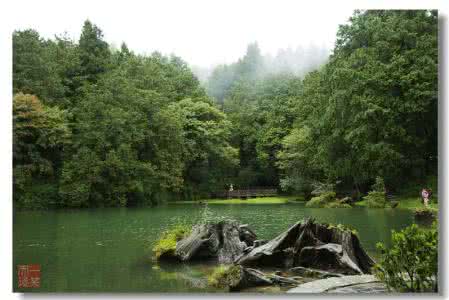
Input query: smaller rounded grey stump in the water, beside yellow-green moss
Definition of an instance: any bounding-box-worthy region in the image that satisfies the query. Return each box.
[174,220,256,263]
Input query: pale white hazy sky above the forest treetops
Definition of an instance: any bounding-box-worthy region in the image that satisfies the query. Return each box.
[6,0,416,66]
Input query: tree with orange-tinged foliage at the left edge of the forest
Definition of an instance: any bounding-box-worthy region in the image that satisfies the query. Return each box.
[13,93,71,208]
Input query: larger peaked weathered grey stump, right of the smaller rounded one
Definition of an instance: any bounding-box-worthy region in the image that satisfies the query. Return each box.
[235,219,374,274]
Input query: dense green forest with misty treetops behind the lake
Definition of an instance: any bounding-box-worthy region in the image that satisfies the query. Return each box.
[13,10,438,208]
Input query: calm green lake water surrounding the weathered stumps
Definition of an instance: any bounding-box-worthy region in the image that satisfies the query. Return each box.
[12,203,413,293]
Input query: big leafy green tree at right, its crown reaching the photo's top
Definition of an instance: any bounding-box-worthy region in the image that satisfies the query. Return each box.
[278,11,438,193]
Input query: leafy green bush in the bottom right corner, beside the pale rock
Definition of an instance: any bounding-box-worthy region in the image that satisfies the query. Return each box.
[374,223,438,292]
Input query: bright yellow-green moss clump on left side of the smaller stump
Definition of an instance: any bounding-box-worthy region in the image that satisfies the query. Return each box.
[153,224,192,259]
